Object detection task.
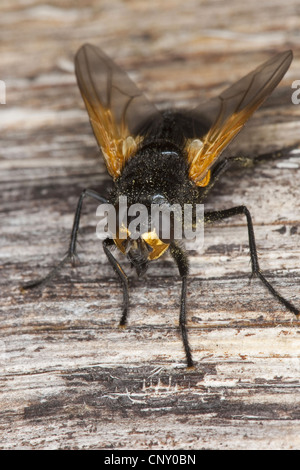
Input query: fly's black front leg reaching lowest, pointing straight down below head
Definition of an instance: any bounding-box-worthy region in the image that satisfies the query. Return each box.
[170,242,194,367]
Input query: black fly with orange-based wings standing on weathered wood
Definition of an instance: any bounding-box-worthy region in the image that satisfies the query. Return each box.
[24,44,299,367]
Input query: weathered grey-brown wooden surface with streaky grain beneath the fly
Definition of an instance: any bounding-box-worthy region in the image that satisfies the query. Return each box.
[0,0,300,449]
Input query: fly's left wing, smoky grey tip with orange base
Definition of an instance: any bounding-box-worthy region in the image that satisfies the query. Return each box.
[75,44,160,179]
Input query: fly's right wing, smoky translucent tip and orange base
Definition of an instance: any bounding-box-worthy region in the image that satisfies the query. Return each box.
[185,51,293,186]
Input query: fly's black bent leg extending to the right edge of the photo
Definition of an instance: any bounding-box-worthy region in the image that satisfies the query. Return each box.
[204,206,300,315]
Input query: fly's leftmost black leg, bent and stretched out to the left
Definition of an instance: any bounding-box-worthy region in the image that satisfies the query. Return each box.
[22,189,108,290]
